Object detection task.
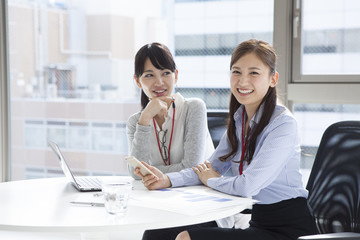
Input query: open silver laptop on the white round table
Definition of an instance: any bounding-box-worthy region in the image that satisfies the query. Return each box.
[48,140,101,192]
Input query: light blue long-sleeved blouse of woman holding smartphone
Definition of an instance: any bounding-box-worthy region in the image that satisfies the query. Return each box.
[167,104,308,204]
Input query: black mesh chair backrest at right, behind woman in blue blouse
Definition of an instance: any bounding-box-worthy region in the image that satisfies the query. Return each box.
[306,121,360,233]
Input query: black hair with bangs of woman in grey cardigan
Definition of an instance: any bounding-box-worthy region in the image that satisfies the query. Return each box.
[135,42,176,109]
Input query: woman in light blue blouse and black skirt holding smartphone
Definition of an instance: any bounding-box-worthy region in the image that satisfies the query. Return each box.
[135,39,317,240]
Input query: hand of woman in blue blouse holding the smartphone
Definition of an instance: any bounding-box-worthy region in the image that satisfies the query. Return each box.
[134,162,171,190]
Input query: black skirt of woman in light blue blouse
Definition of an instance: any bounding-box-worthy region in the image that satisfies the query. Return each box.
[188,198,318,240]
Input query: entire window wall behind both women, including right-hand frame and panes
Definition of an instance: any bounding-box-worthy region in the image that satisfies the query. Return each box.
[0,0,360,186]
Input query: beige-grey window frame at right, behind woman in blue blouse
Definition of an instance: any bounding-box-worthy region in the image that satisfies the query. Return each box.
[273,0,360,105]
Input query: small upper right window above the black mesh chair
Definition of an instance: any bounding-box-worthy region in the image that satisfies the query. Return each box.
[293,0,360,82]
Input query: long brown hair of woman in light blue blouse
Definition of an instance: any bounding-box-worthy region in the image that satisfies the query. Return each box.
[220,39,277,164]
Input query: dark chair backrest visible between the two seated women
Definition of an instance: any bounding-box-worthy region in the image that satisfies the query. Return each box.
[207,111,229,148]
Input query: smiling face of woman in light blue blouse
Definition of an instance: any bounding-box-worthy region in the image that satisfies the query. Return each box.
[230,53,278,110]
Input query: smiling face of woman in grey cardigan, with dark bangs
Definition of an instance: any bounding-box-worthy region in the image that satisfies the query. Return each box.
[135,58,178,99]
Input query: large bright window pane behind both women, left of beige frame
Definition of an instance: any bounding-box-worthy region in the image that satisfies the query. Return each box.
[7,0,274,180]
